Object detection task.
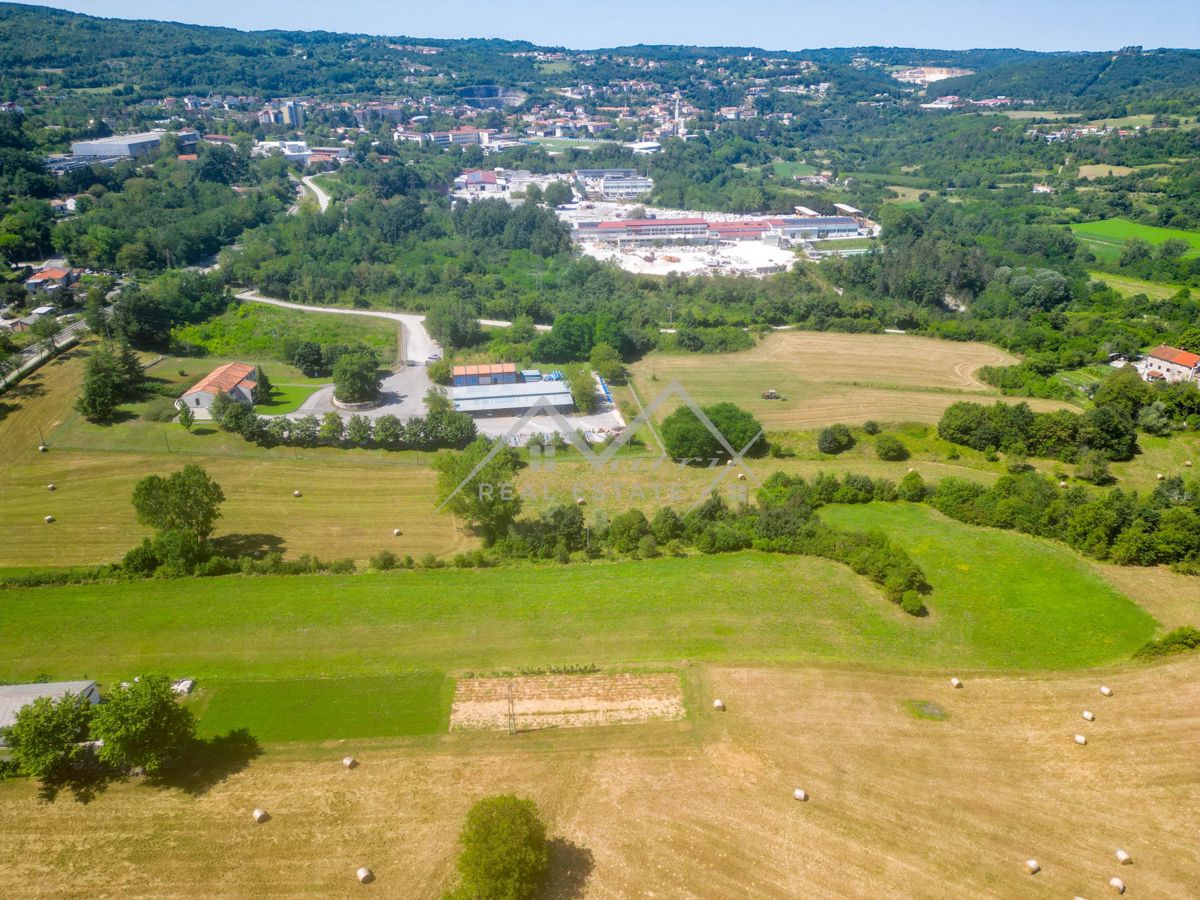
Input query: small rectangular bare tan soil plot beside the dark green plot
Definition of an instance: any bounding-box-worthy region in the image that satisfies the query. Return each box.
[450,674,684,731]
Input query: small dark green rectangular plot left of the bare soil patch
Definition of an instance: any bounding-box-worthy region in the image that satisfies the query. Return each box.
[188,673,454,742]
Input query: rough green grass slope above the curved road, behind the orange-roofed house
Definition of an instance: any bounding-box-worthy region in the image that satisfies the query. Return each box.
[173,304,400,364]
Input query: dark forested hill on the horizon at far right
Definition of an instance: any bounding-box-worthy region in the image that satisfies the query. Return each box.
[936,48,1200,109]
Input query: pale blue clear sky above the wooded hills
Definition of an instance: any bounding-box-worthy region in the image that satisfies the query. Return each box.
[9,0,1200,50]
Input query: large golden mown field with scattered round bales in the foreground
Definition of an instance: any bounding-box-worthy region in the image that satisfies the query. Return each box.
[0,658,1200,900]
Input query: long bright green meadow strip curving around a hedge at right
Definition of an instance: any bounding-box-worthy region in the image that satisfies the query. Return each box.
[0,513,1154,683]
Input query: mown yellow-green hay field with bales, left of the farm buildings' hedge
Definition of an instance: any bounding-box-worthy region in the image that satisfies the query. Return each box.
[0,349,470,568]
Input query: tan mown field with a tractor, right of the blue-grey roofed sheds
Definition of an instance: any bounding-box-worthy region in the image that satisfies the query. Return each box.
[631,331,1068,431]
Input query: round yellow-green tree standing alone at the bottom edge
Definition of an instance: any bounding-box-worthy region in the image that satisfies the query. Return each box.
[452,794,550,900]
